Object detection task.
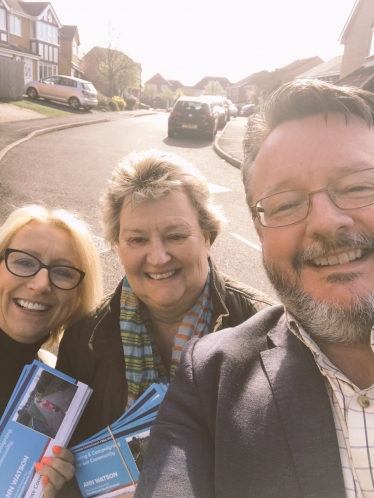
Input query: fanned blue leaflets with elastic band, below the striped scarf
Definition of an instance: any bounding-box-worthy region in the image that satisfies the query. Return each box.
[70,384,167,498]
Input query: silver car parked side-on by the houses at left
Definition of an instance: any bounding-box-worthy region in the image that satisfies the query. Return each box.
[24,75,97,110]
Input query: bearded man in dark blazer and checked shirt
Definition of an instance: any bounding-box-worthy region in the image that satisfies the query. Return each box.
[136,81,374,498]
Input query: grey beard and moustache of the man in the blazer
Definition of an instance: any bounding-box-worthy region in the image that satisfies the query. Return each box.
[263,231,374,344]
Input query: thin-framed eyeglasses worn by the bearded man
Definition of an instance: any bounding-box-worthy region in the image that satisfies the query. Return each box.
[250,168,374,228]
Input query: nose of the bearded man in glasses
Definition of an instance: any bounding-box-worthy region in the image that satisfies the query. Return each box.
[306,191,354,239]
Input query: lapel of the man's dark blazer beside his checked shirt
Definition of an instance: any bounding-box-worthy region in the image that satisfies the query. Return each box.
[261,320,345,498]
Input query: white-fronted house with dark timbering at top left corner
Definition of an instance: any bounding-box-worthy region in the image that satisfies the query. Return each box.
[0,0,61,83]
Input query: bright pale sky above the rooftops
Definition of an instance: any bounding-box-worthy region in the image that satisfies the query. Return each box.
[51,0,355,85]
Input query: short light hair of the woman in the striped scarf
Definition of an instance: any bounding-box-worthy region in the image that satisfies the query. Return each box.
[100,150,224,248]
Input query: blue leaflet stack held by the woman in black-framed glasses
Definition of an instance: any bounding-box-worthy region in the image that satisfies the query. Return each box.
[0,361,92,498]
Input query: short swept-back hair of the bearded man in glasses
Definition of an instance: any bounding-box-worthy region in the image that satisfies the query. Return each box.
[242,80,374,211]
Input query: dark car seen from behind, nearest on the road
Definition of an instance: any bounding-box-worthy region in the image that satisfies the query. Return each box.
[168,97,218,140]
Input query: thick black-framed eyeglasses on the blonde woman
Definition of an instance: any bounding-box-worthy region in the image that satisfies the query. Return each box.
[4,249,85,290]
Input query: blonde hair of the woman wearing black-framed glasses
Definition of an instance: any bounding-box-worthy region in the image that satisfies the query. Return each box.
[0,205,102,342]
